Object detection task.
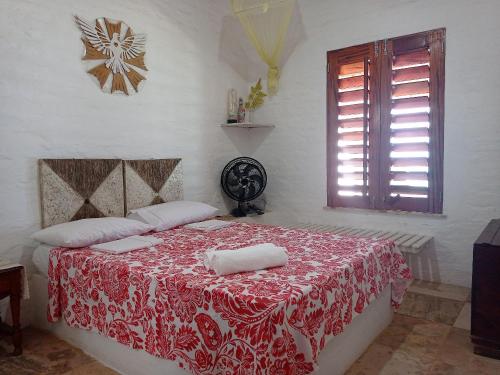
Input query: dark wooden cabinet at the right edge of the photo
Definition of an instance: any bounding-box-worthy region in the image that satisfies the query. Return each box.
[471,219,500,359]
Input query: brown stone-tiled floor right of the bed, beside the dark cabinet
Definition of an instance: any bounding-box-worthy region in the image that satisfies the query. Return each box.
[348,281,500,375]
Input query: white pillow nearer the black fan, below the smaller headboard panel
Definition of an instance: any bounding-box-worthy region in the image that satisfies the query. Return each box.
[127,201,218,232]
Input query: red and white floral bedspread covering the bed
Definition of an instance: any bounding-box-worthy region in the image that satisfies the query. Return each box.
[48,223,411,375]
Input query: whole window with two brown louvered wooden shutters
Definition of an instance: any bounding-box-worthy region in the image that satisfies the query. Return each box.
[327,29,445,213]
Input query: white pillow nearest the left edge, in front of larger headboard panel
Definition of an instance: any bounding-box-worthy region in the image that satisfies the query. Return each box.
[31,217,153,247]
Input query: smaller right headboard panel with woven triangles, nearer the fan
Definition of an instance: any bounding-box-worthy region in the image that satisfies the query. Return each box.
[123,159,183,211]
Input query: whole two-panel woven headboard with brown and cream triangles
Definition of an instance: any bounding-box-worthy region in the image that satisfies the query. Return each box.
[39,159,183,228]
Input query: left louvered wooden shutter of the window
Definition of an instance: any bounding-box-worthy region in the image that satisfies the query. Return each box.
[327,44,377,208]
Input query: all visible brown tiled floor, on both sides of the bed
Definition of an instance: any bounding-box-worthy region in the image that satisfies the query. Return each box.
[0,281,500,375]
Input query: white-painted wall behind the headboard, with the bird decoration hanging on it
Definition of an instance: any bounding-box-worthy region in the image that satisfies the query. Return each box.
[0,0,247,261]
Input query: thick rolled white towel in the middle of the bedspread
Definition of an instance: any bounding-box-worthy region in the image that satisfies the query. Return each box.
[205,243,288,276]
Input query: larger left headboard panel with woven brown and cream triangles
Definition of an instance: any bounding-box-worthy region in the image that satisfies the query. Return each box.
[39,159,125,228]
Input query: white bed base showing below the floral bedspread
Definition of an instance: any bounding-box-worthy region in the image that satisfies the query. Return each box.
[31,274,393,375]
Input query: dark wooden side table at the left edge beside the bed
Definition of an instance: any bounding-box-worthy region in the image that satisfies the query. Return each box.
[0,265,23,356]
